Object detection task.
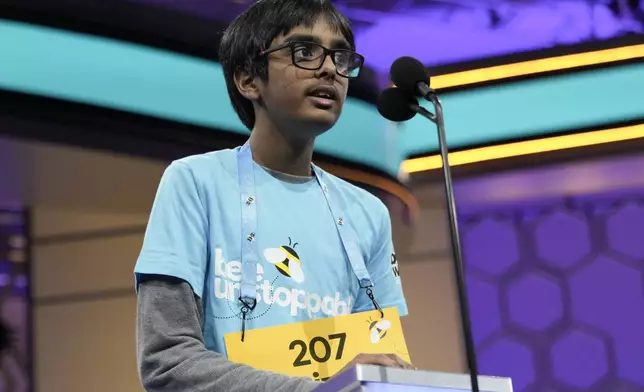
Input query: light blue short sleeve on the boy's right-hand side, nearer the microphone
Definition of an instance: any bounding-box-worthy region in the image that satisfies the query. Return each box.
[354,203,408,317]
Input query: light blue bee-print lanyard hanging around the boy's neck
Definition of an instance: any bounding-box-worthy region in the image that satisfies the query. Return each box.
[237,141,382,341]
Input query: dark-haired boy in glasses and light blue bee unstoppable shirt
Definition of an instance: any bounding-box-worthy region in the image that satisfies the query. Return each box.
[135,0,411,392]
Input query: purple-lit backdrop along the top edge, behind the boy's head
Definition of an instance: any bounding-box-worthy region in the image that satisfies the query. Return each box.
[128,0,644,74]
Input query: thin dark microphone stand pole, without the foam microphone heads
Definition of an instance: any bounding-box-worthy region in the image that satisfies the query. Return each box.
[409,95,479,392]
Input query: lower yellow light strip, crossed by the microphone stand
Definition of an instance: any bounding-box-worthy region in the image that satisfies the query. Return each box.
[402,124,644,173]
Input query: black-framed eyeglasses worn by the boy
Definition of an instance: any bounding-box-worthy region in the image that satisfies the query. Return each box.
[259,41,364,79]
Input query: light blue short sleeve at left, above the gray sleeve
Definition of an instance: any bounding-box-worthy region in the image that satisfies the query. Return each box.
[134,161,209,297]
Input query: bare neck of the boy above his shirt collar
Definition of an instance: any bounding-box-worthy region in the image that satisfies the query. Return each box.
[250,126,315,176]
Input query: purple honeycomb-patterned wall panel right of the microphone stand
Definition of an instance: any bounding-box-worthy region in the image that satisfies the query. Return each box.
[459,189,644,392]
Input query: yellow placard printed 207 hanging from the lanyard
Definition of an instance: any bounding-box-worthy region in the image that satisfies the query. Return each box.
[224,308,411,381]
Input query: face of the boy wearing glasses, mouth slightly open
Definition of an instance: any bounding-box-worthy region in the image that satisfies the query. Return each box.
[257,18,350,137]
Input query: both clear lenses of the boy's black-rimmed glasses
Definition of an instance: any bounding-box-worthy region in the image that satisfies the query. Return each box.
[293,42,362,78]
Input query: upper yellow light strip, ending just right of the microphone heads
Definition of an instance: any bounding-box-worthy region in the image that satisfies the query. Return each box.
[432,44,644,90]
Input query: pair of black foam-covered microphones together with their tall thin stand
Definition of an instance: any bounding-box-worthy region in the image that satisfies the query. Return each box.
[378,57,480,392]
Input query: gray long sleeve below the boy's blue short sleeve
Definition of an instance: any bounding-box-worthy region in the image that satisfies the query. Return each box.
[137,276,319,392]
